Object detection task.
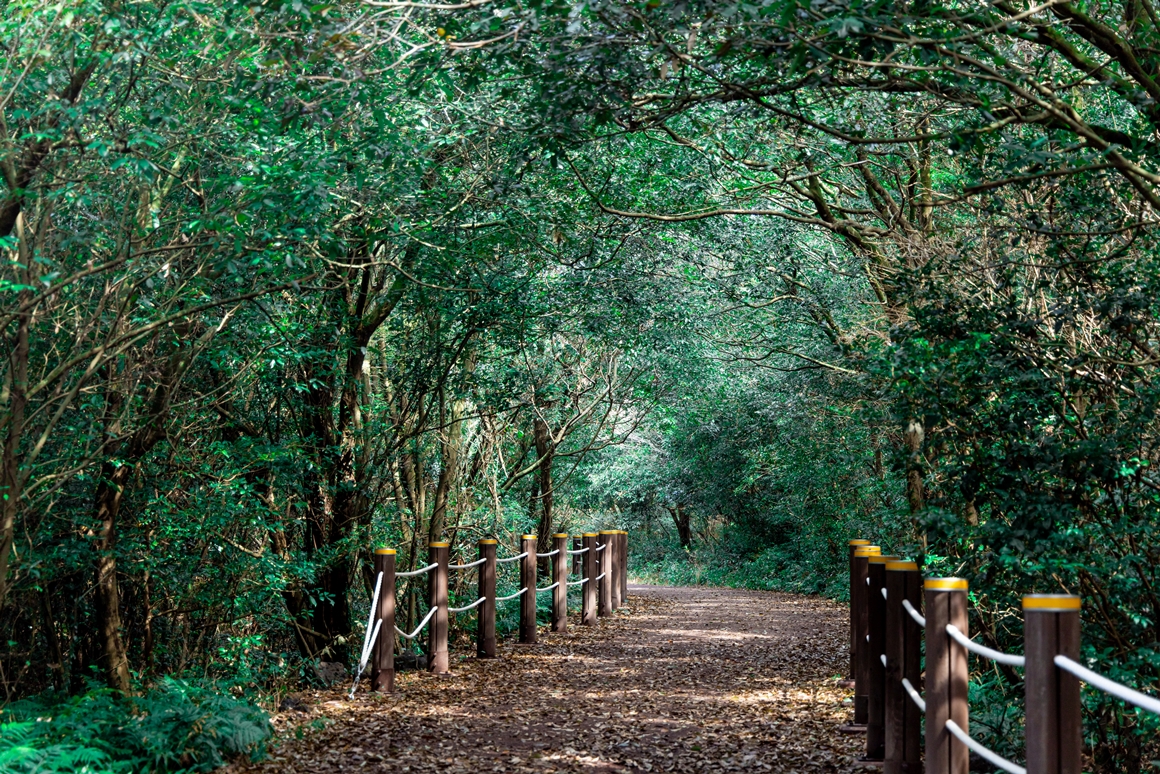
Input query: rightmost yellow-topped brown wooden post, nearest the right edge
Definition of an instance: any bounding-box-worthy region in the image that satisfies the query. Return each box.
[1023,594,1083,774]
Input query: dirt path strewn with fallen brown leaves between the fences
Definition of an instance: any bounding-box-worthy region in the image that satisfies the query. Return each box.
[241,586,862,774]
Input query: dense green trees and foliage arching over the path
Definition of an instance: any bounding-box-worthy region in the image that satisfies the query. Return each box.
[0,0,1160,772]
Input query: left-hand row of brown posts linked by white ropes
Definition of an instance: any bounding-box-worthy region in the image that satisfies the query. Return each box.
[350,529,629,697]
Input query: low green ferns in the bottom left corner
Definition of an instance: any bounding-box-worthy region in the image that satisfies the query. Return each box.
[0,679,273,774]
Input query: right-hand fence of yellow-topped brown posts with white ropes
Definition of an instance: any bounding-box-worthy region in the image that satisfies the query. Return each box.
[844,540,1160,774]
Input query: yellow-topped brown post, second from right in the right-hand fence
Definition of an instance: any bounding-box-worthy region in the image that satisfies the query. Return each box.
[923,578,969,774]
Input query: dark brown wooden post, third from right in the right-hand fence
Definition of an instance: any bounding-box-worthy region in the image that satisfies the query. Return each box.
[883,562,922,774]
